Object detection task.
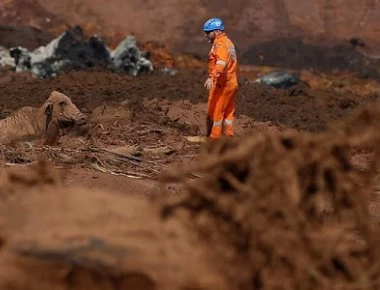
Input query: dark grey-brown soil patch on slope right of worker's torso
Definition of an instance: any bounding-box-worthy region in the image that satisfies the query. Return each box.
[241,38,380,78]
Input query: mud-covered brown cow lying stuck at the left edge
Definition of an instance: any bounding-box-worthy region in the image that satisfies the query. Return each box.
[0,91,86,145]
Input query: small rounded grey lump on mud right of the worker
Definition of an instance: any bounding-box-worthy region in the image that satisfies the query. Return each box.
[255,72,302,89]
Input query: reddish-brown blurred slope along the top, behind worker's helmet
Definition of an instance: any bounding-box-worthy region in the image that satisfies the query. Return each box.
[37,0,380,54]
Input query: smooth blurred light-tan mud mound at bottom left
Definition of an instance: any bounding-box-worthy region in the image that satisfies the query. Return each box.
[0,162,230,290]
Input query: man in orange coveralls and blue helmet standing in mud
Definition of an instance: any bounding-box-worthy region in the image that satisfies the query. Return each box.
[203,18,238,139]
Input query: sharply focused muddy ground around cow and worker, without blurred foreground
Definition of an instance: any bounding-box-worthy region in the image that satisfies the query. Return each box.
[0,66,379,182]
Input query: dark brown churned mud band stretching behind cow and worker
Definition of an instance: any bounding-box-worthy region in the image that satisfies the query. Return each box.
[0,70,378,131]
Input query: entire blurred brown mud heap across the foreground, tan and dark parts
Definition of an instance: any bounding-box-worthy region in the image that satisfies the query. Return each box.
[0,106,380,290]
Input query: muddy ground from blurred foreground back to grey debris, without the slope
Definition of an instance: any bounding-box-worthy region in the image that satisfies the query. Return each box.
[0,47,380,290]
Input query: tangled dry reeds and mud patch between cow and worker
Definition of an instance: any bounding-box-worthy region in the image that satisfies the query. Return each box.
[0,97,198,178]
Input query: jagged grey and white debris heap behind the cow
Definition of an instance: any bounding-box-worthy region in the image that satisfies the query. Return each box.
[4,26,153,78]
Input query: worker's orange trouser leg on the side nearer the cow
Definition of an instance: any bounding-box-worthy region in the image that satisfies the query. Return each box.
[207,86,225,139]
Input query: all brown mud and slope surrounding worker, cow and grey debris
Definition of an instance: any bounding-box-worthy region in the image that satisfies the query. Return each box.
[0,0,380,290]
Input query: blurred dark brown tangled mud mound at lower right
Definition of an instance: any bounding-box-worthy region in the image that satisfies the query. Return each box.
[162,106,380,289]
